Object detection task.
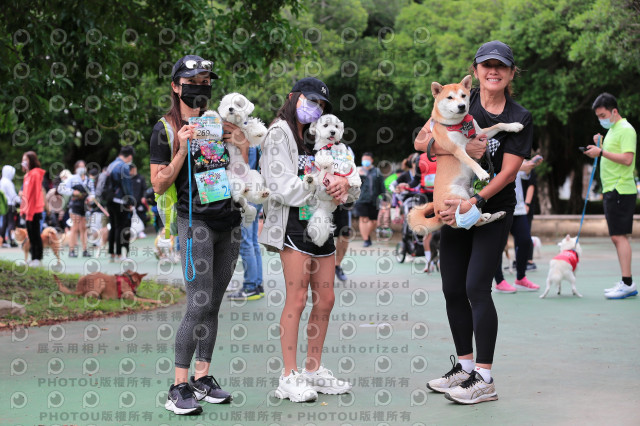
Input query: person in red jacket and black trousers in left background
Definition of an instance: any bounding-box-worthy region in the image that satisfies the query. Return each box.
[20,151,45,266]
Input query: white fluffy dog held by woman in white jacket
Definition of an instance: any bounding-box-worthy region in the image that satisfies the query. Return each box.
[305,114,362,246]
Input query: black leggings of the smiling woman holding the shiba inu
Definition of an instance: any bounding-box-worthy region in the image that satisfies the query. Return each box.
[440,213,513,364]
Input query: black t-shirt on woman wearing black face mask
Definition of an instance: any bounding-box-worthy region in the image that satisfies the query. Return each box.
[149,121,241,231]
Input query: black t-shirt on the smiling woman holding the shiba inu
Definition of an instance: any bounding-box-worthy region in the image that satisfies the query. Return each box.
[469,89,533,213]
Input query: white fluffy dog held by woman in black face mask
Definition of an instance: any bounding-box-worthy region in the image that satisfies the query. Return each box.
[204,93,269,225]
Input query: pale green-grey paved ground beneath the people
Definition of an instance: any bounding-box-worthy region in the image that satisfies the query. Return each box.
[0,238,640,425]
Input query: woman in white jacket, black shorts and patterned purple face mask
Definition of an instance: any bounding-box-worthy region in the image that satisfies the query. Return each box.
[258,77,359,402]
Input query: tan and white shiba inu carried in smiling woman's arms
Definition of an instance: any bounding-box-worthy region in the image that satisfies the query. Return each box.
[408,75,524,235]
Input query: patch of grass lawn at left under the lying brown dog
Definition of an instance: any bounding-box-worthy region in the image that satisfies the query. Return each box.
[0,260,184,330]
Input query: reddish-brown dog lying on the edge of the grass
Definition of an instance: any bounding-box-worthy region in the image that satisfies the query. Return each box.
[53,270,162,304]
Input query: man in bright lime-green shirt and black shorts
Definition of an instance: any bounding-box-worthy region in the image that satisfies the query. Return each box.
[584,93,638,299]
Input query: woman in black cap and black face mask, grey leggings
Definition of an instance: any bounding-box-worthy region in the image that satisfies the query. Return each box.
[149,55,249,414]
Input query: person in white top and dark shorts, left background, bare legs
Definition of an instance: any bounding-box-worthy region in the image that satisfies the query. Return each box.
[58,160,95,257]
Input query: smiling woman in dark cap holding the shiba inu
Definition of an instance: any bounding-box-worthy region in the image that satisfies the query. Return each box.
[415,41,533,404]
